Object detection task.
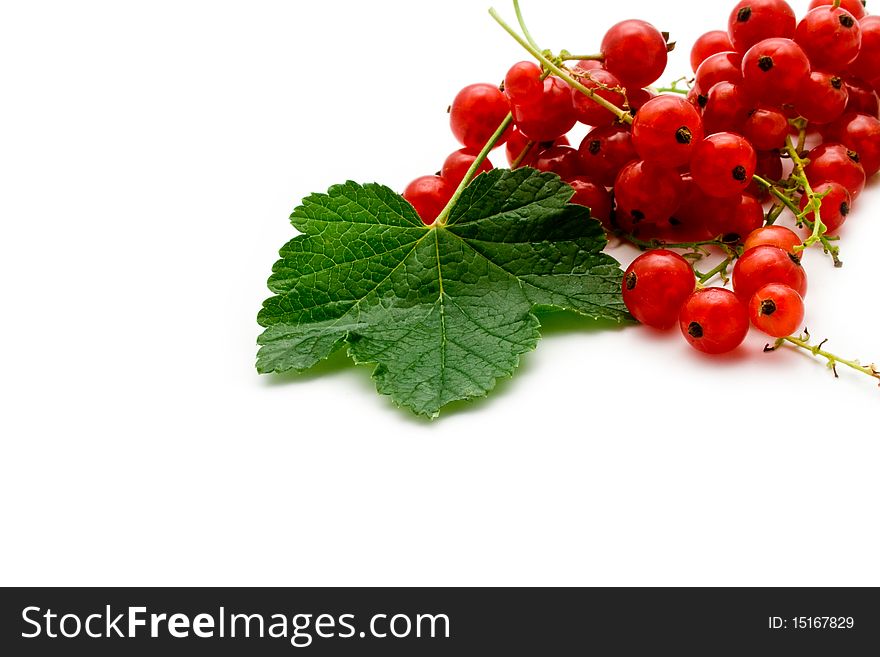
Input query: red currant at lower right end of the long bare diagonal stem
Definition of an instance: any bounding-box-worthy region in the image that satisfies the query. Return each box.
[632,96,703,168]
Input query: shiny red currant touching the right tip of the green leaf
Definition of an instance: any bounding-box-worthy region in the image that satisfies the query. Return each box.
[623,249,696,330]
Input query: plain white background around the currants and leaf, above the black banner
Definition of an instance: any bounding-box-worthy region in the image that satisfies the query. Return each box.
[0,0,880,585]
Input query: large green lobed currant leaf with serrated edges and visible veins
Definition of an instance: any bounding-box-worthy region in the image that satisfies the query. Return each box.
[257,168,628,417]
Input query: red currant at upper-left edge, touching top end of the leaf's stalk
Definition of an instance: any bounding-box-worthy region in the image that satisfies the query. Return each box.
[449,84,510,150]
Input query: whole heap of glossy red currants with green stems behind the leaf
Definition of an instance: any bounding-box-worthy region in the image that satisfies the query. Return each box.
[404,0,880,364]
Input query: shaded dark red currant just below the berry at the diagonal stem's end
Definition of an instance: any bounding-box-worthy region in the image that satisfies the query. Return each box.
[614,160,684,227]
